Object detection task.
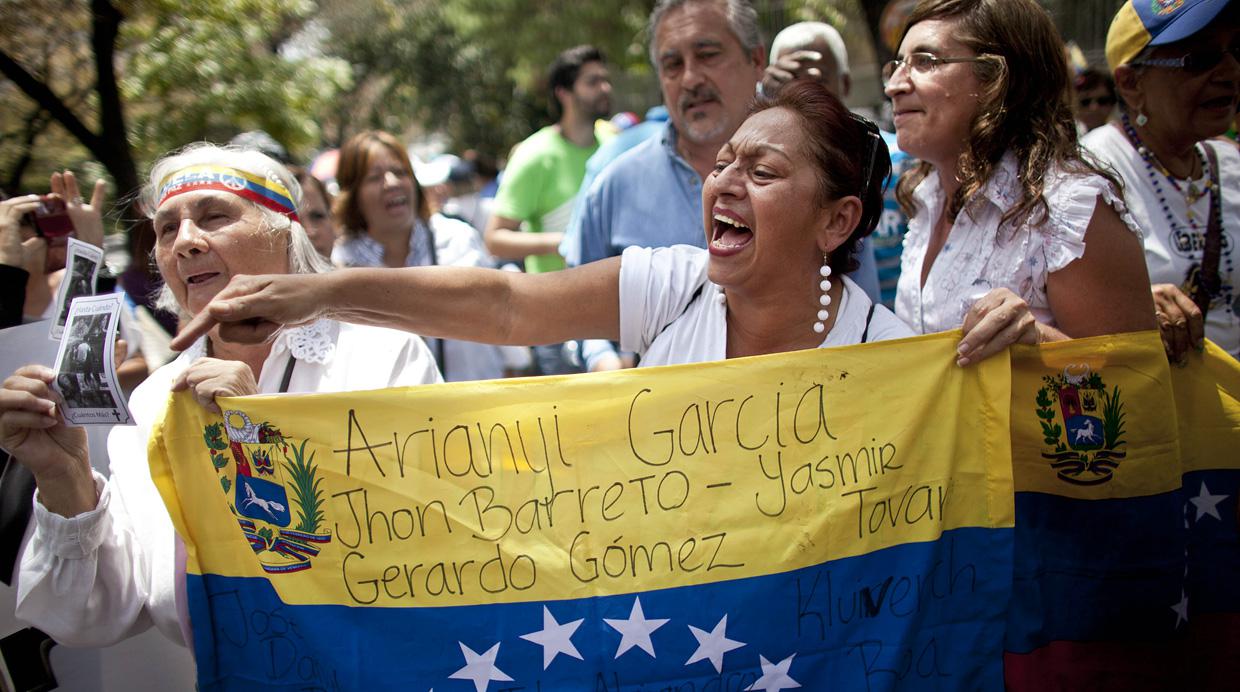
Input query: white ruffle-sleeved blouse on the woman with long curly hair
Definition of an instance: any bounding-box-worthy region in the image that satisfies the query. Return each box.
[895,153,1141,334]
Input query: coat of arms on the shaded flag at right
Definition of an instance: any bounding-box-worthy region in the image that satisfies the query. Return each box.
[1035,365,1126,485]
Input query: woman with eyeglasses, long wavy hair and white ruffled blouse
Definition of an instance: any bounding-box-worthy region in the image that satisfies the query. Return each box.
[883,0,1153,365]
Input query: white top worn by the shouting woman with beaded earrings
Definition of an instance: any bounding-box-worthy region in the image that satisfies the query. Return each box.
[620,246,913,366]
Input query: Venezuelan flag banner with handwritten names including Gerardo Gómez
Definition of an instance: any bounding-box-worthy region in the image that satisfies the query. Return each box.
[151,334,1016,692]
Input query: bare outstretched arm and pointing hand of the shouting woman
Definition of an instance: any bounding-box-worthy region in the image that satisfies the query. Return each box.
[172,257,620,350]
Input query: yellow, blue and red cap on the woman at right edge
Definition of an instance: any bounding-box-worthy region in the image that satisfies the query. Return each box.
[1106,0,1231,72]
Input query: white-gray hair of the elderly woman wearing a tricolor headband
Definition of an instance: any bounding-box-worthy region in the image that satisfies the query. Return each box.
[141,141,331,314]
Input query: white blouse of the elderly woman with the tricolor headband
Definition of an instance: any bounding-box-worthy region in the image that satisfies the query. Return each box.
[16,320,441,646]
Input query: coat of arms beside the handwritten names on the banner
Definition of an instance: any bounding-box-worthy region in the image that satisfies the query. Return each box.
[202,410,331,574]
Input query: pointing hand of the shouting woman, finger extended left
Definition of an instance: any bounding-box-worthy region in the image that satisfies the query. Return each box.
[171,274,324,351]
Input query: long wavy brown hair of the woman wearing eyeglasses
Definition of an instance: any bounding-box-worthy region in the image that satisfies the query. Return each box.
[895,0,1122,230]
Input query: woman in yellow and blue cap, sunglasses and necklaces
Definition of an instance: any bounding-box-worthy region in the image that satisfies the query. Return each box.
[1084,0,1240,362]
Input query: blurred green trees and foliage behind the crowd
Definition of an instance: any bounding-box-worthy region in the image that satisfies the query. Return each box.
[0,0,1118,225]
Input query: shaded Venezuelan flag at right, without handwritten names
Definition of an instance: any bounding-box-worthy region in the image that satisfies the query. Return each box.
[1006,332,1240,691]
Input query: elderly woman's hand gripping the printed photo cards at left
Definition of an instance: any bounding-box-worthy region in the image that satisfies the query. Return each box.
[0,365,91,487]
